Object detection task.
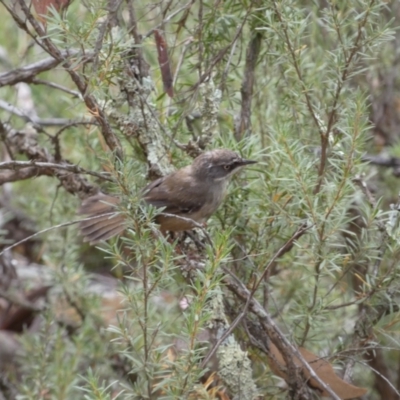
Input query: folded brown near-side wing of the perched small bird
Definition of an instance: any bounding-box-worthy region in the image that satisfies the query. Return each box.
[143,171,206,214]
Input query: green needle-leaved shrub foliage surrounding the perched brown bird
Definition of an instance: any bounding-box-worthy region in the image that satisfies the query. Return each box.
[0,0,400,399]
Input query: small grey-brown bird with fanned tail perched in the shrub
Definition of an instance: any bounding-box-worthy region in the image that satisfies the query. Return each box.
[79,149,257,244]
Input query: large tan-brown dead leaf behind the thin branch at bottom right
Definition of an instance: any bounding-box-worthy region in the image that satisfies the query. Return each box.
[268,342,367,400]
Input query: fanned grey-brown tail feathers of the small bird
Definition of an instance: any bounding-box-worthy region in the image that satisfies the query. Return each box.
[78,194,126,244]
